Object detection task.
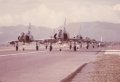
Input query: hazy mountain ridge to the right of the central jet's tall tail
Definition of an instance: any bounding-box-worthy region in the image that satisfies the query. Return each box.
[67,22,120,41]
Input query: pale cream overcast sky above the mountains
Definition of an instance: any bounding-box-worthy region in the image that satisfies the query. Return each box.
[0,0,120,28]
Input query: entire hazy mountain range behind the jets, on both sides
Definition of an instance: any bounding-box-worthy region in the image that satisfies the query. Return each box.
[0,22,120,43]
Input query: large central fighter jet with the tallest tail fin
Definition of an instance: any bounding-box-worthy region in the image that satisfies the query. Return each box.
[45,18,85,51]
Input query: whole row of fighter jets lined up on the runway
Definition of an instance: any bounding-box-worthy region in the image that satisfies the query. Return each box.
[10,19,102,51]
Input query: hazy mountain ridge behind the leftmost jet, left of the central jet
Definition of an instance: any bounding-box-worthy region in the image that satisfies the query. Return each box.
[0,25,52,43]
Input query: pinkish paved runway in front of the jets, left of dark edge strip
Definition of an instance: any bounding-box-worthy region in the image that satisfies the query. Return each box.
[0,48,103,82]
